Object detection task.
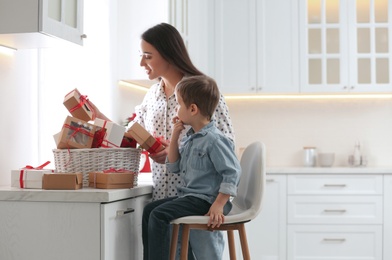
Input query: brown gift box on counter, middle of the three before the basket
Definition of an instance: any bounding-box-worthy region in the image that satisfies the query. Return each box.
[42,173,83,190]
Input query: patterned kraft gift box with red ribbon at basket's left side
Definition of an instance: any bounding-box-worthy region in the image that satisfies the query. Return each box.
[54,116,97,149]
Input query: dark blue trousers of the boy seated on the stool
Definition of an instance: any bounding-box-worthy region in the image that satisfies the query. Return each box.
[142,196,222,260]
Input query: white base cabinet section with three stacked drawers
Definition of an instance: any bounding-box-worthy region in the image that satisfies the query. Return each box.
[287,175,383,260]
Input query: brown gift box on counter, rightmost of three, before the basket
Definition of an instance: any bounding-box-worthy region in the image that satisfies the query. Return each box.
[89,169,135,189]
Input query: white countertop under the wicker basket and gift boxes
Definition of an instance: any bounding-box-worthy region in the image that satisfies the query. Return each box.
[0,184,152,203]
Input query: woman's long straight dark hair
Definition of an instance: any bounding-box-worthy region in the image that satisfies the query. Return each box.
[141,23,204,76]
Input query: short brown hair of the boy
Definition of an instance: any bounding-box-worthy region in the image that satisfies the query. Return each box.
[176,75,220,119]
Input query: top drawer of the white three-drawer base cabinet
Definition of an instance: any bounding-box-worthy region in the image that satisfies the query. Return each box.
[288,175,383,195]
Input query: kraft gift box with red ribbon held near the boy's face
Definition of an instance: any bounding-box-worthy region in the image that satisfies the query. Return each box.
[125,122,164,153]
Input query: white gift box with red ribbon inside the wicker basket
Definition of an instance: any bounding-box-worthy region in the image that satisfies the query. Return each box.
[94,118,125,148]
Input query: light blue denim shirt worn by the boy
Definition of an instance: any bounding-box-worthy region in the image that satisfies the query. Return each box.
[166,121,241,214]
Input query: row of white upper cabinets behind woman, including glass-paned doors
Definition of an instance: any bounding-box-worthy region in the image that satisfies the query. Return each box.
[161,0,392,94]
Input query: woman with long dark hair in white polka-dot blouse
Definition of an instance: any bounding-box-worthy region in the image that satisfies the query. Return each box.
[96,23,234,259]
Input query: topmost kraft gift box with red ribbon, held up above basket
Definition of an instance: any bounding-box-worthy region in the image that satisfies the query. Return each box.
[63,88,94,121]
